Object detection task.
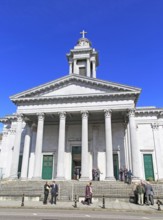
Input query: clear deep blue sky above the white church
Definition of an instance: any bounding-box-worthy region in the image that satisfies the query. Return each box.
[0,0,163,129]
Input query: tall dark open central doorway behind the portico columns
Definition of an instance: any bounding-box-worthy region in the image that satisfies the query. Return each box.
[71,146,81,180]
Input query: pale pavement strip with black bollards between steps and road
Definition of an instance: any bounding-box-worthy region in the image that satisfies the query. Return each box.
[0,198,163,213]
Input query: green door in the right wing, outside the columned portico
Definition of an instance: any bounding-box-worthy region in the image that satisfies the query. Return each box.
[144,154,154,180]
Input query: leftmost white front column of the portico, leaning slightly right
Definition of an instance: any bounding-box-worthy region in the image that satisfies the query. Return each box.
[10,114,23,179]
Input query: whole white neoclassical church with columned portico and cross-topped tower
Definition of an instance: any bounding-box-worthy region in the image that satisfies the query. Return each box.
[0,31,163,181]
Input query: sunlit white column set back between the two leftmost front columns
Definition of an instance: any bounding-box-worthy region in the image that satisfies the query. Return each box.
[21,124,31,179]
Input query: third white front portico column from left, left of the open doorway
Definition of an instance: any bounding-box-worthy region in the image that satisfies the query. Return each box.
[56,112,66,180]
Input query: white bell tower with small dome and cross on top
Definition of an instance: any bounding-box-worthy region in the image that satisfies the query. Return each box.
[67,30,99,78]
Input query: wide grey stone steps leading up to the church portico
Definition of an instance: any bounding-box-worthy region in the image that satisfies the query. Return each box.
[0,180,163,201]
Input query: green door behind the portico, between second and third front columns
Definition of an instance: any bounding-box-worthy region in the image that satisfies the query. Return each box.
[42,155,53,180]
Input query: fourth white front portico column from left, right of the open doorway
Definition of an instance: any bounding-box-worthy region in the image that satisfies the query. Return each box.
[80,111,89,181]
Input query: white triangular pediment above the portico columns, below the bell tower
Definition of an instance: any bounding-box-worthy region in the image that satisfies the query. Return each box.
[10,75,140,101]
